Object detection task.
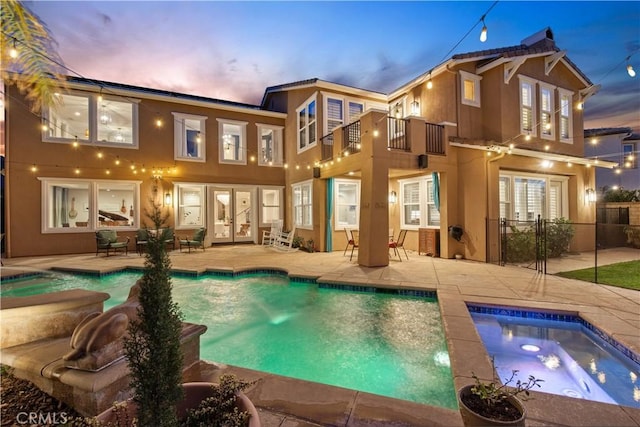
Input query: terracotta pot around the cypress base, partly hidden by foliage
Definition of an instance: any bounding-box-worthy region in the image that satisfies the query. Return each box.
[96,382,262,427]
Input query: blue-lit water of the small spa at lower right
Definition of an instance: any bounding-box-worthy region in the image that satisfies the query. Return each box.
[470,307,640,408]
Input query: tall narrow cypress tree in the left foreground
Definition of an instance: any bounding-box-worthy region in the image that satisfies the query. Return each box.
[124,185,182,427]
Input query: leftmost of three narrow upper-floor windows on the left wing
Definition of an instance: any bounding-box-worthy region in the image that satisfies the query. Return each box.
[172,113,207,162]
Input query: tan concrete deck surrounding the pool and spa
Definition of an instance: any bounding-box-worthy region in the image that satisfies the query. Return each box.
[0,245,640,427]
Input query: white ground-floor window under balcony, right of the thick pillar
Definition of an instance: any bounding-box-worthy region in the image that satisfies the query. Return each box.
[399,177,440,230]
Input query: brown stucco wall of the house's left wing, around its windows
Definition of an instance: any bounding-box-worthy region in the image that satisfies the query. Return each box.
[5,86,286,257]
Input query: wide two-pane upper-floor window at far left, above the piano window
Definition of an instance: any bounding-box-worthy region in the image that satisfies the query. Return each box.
[42,92,138,148]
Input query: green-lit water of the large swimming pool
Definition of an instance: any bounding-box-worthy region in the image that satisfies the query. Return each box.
[1,273,457,409]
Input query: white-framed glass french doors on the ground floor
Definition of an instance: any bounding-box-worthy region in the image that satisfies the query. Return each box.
[208,187,252,243]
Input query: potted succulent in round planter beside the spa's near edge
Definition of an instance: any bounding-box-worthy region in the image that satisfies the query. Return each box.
[458,369,543,427]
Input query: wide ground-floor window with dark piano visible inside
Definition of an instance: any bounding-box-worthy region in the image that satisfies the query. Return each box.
[42,178,140,233]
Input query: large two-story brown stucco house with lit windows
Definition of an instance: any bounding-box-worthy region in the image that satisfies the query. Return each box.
[4,29,614,266]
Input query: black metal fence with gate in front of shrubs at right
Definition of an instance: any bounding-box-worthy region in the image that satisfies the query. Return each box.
[486,218,640,283]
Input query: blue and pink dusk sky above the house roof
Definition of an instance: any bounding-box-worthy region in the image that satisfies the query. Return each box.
[25,1,640,132]
